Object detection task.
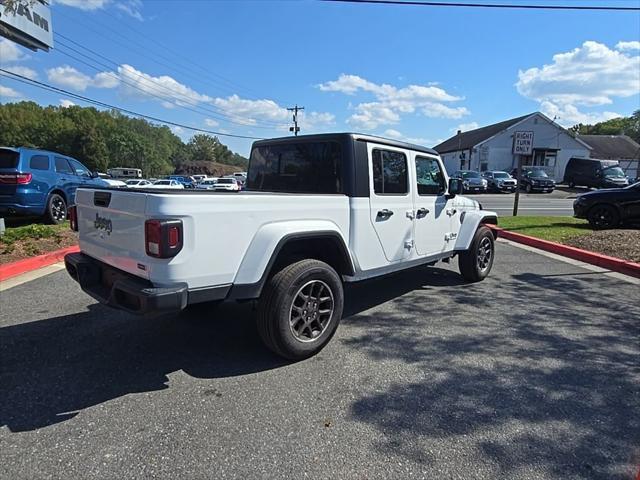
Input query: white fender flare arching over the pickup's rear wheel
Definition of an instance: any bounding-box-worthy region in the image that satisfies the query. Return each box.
[228,221,355,299]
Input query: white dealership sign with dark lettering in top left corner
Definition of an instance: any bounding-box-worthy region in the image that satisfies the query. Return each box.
[0,0,53,51]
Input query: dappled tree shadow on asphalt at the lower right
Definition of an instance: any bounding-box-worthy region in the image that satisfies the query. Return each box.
[343,273,640,479]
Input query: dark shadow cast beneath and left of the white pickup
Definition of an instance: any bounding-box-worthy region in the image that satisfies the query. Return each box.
[0,269,460,432]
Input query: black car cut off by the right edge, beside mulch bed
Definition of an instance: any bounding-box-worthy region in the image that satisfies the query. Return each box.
[573,182,640,229]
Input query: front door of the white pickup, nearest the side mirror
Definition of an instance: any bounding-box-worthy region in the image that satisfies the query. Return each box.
[412,153,457,256]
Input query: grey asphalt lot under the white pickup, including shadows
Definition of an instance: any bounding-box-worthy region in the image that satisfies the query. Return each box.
[0,243,640,480]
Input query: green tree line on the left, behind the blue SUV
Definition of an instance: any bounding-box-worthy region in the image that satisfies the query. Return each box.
[0,102,248,177]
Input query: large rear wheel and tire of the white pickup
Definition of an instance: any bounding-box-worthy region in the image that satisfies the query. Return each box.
[257,259,344,360]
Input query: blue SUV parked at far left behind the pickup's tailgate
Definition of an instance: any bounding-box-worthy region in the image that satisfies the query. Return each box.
[0,147,101,223]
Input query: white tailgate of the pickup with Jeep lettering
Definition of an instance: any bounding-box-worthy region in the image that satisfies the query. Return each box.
[76,188,149,279]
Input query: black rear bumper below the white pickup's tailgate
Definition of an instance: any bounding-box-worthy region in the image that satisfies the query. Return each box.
[64,253,189,315]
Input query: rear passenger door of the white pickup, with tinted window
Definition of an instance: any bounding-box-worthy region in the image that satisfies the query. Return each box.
[367,143,413,262]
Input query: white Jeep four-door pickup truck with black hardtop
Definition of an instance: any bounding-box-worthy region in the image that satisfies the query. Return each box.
[65,133,497,359]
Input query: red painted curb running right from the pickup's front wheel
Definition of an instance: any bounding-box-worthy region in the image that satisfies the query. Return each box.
[488,225,640,278]
